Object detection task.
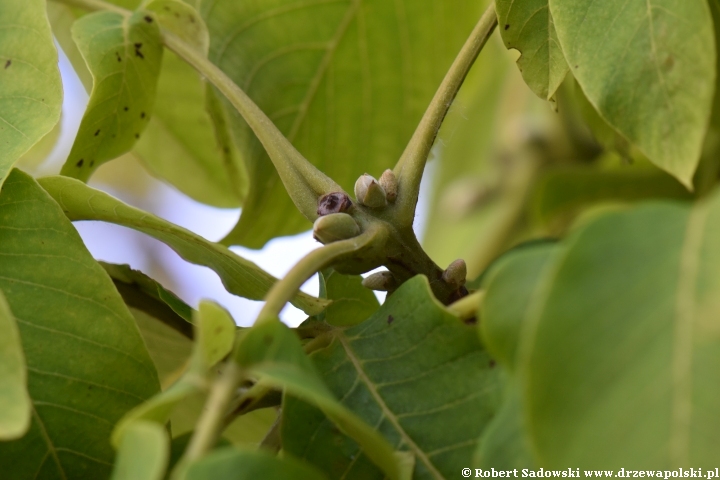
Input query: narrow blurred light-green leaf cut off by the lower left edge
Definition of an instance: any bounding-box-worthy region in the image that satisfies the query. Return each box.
[0,292,32,440]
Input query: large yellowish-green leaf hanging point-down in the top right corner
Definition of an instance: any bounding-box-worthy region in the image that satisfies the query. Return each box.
[550,0,716,188]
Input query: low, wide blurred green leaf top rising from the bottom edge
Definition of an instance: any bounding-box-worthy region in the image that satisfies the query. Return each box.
[184,448,327,480]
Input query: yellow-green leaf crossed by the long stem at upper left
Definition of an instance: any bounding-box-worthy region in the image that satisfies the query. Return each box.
[135,0,247,207]
